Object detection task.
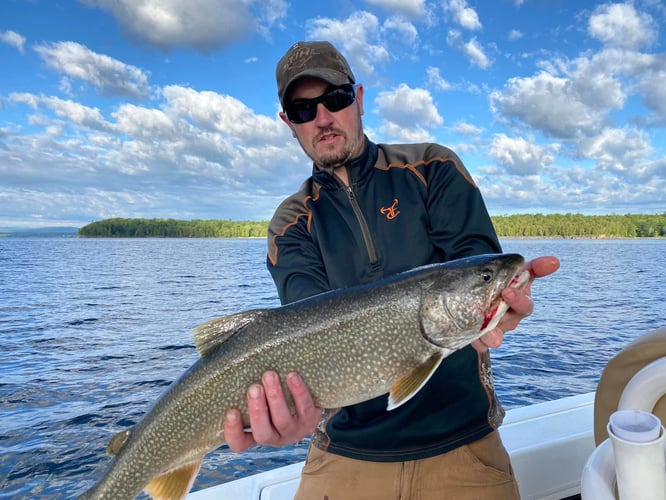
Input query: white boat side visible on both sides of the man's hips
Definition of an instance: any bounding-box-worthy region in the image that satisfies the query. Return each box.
[187,392,595,500]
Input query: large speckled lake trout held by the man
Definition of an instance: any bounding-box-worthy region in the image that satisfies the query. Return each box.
[82,254,529,500]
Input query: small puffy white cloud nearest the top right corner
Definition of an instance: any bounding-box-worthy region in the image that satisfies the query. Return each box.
[587,3,658,49]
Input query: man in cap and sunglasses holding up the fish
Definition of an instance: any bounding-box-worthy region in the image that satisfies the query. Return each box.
[224,42,559,500]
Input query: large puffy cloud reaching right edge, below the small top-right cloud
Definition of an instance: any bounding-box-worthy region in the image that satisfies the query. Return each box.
[490,31,666,139]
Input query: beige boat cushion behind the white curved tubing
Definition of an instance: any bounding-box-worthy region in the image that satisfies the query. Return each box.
[594,327,666,446]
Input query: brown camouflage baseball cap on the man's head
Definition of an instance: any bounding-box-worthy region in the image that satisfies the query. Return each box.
[275,42,356,108]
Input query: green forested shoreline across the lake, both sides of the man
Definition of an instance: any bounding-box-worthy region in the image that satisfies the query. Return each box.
[77,212,666,238]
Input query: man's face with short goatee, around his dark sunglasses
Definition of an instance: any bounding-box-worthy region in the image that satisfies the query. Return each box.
[280,78,364,168]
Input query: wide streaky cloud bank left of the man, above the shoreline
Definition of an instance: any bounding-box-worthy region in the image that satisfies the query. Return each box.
[0,86,304,224]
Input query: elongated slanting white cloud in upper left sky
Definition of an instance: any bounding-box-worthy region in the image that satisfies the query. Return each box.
[35,42,149,99]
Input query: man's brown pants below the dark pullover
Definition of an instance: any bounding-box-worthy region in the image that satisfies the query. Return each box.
[294,431,520,500]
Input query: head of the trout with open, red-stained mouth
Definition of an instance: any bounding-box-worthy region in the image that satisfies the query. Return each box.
[420,254,530,350]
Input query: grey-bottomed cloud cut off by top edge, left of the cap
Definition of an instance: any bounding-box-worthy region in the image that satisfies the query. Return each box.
[84,0,287,52]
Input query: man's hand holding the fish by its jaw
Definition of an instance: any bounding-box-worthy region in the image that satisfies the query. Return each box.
[472,257,560,352]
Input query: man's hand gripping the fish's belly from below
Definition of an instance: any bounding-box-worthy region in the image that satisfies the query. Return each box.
[224,371,322,452]
